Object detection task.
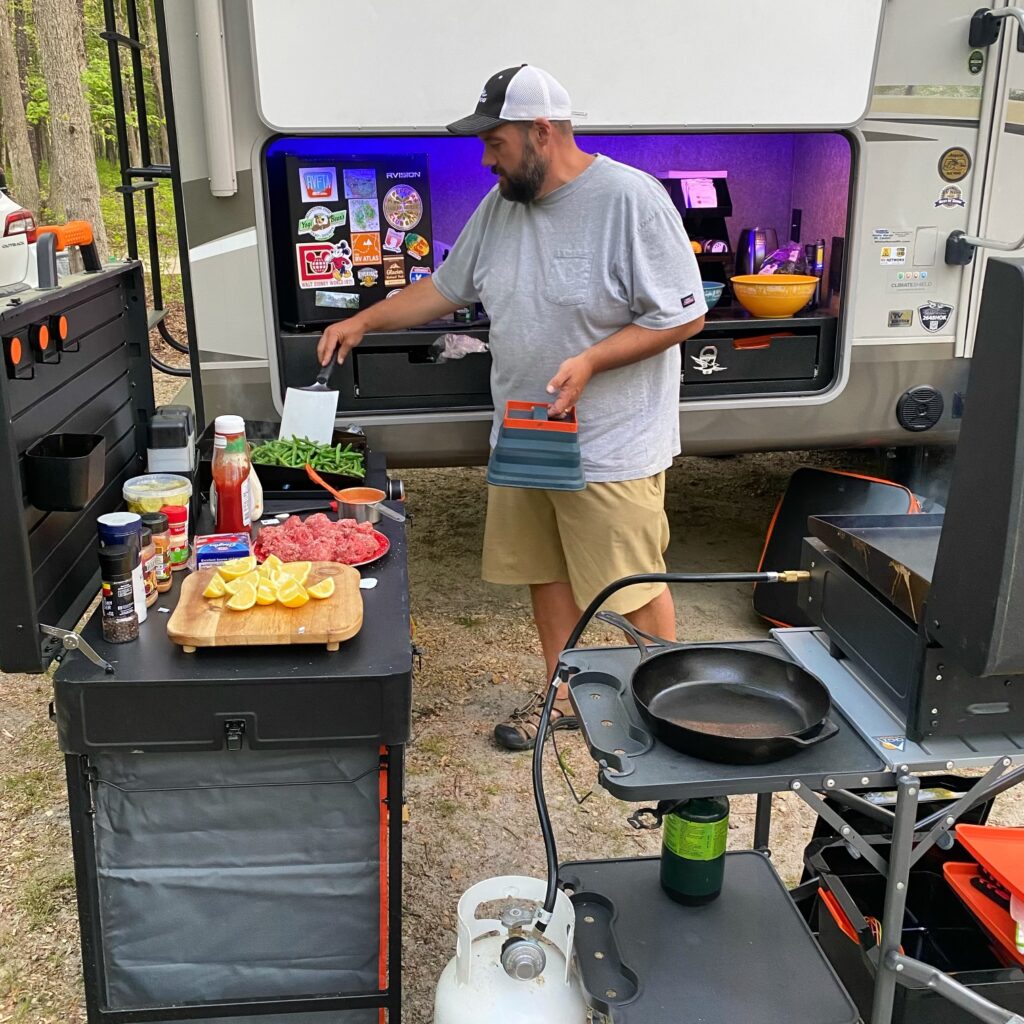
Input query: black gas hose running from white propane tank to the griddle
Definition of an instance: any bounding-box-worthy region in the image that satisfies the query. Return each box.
[534,570,809,932]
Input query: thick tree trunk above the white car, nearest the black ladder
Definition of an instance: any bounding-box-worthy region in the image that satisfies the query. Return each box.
[33,0,106,260]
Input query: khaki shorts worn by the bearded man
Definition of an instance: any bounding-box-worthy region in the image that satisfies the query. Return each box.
[482,473,669,614]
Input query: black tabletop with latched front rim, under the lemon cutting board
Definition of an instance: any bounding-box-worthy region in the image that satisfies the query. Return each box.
[54,512,413,754]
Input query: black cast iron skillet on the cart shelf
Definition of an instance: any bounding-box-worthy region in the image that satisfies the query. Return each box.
[597,611,839,764]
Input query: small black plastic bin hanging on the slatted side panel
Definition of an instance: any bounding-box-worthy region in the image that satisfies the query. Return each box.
[25,434,106,512]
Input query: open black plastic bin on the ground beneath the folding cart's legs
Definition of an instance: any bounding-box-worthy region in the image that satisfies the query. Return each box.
[808,841,1024,1024]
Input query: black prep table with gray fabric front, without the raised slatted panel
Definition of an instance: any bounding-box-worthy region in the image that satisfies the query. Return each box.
[53,507,413,1024]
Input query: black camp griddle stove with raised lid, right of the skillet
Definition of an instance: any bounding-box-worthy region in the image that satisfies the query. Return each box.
[779,259,1024,749]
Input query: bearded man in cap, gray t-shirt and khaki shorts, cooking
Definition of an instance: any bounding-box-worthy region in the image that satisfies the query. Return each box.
[317,65,707,750]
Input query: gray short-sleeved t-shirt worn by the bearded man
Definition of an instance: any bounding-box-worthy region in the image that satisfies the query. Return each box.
[434,156,708,482]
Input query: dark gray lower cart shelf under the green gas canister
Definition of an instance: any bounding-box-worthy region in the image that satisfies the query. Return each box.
[560,851,857,1024]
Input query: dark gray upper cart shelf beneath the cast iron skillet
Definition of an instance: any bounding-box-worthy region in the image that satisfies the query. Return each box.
[562,640,895,801]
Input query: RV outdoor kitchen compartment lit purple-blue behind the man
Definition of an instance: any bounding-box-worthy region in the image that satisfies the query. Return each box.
[263,132,855,417]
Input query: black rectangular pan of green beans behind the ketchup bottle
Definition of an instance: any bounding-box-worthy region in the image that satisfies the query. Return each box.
[199,420,367,492]
